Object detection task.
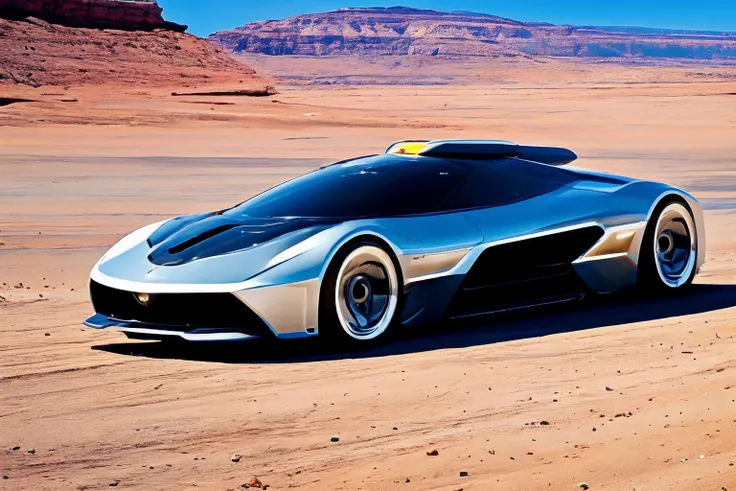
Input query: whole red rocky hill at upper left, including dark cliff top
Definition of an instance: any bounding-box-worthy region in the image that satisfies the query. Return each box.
[0,0,263,89]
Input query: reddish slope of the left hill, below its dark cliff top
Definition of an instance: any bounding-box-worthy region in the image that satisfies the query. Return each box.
[0,18,258,89]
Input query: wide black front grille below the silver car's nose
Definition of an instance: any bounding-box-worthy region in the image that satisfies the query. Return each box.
[90,281,270,335]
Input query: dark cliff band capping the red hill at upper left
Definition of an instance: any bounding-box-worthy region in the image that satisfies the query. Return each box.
[0,0,187,32]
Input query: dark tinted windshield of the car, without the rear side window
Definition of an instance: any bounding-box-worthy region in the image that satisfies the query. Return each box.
[225,155,466,218]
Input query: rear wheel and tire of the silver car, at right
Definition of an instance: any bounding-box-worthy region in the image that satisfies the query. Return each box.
[637,198,699,293]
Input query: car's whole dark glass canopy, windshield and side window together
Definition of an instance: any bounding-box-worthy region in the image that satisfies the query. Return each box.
[225,155,578,219]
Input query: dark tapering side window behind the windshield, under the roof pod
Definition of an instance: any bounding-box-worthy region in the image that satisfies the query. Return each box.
[444,160,574,210]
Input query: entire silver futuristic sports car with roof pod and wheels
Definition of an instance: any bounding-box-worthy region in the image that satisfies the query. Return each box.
[85,140,705,342]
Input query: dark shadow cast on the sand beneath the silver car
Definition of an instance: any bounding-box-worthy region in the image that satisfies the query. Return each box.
[92,285,736,363]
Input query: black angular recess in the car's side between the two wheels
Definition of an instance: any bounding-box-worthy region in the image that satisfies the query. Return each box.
[448,226,603,317]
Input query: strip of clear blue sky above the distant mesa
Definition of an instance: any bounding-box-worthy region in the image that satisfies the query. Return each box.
[158,0,736,36]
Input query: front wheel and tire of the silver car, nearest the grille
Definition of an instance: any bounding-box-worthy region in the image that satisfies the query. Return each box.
[319,240,401,345]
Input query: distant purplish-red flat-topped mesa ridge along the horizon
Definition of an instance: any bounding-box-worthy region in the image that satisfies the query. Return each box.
[210,7,736,60]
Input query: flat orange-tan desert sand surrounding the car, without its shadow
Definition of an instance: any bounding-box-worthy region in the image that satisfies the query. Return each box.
[0,62,736,491]
